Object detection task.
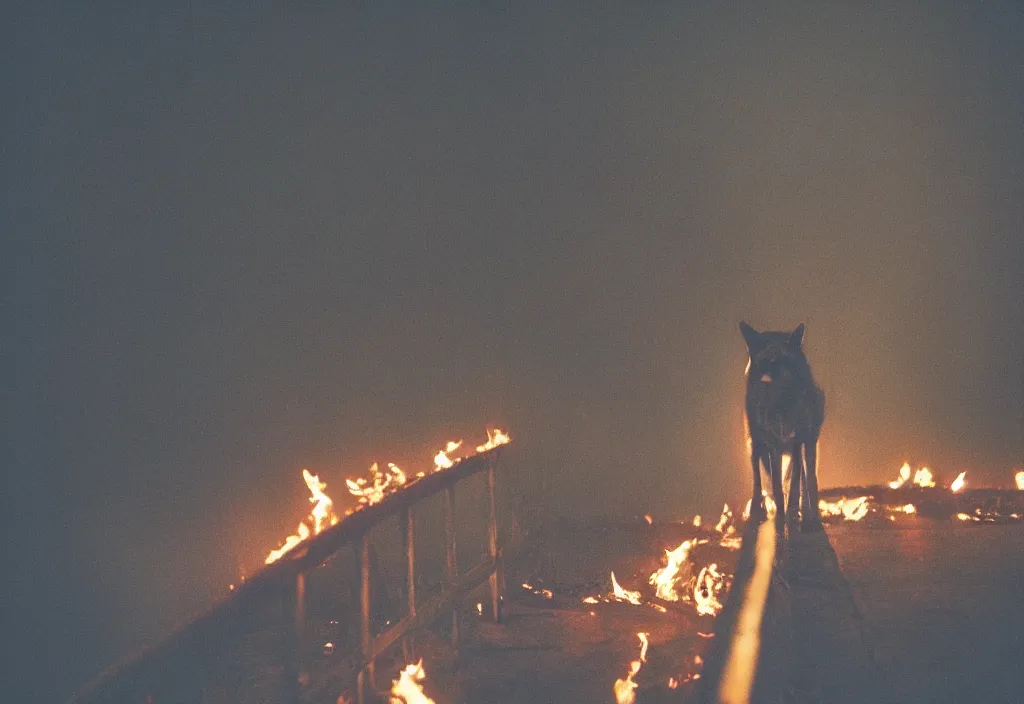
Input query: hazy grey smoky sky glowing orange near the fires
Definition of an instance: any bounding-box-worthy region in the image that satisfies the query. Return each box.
[0,2,1024,701]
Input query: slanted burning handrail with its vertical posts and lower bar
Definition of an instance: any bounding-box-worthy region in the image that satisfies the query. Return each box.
[68,446,501,704]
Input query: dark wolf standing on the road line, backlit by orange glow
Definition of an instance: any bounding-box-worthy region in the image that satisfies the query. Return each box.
[739,320,825,533]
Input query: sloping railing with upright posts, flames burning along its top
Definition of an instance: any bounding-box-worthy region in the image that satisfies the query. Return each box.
[69,446,502,704]
